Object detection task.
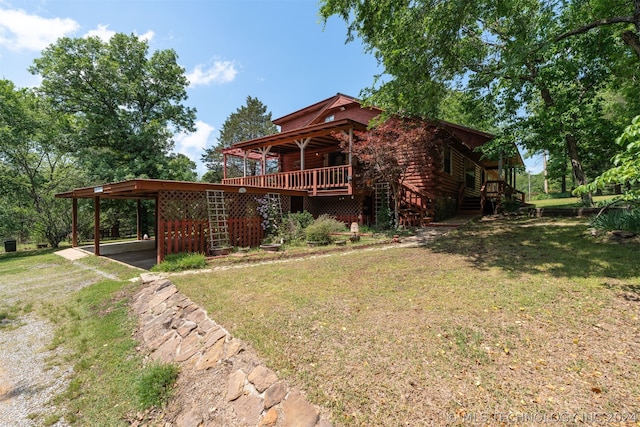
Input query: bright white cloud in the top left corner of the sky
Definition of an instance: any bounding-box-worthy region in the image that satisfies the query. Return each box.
[0,9,80,52]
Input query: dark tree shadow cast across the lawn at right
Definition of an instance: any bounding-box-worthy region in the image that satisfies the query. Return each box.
[430,218,640,282]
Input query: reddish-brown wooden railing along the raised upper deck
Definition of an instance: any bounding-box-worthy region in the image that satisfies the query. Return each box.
[222,166,352,195]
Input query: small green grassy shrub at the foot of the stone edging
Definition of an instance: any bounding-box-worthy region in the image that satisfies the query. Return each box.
[137,363,180,409]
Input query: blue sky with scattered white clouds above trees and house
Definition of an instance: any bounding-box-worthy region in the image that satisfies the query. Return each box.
[0,0,544,174]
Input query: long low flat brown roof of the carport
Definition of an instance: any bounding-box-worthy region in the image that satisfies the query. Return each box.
[56,179,307,199]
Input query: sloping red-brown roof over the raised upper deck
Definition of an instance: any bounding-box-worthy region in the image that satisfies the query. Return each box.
[223,119,367,155]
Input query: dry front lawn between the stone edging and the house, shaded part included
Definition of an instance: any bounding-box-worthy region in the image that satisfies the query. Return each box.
[172,218,640,426]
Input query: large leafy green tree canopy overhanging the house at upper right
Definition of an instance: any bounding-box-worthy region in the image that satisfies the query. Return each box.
[321,0,640,203]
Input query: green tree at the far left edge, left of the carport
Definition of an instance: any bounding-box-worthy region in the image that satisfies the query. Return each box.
[0,80,82,247]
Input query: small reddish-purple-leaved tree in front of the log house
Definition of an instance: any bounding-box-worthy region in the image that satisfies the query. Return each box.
[334,117,441,225]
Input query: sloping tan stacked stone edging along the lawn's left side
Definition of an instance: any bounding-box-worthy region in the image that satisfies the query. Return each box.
[133,274,331,427]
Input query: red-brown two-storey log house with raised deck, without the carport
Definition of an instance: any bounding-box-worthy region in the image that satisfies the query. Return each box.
[223,93,524,226]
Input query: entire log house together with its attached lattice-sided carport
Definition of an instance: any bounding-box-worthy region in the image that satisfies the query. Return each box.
[56,93,524,263]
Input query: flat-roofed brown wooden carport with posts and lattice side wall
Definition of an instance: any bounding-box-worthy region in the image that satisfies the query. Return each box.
[56,179,307,263]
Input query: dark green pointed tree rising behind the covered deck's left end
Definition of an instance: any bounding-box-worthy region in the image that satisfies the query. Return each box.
[202,96,278,182]
